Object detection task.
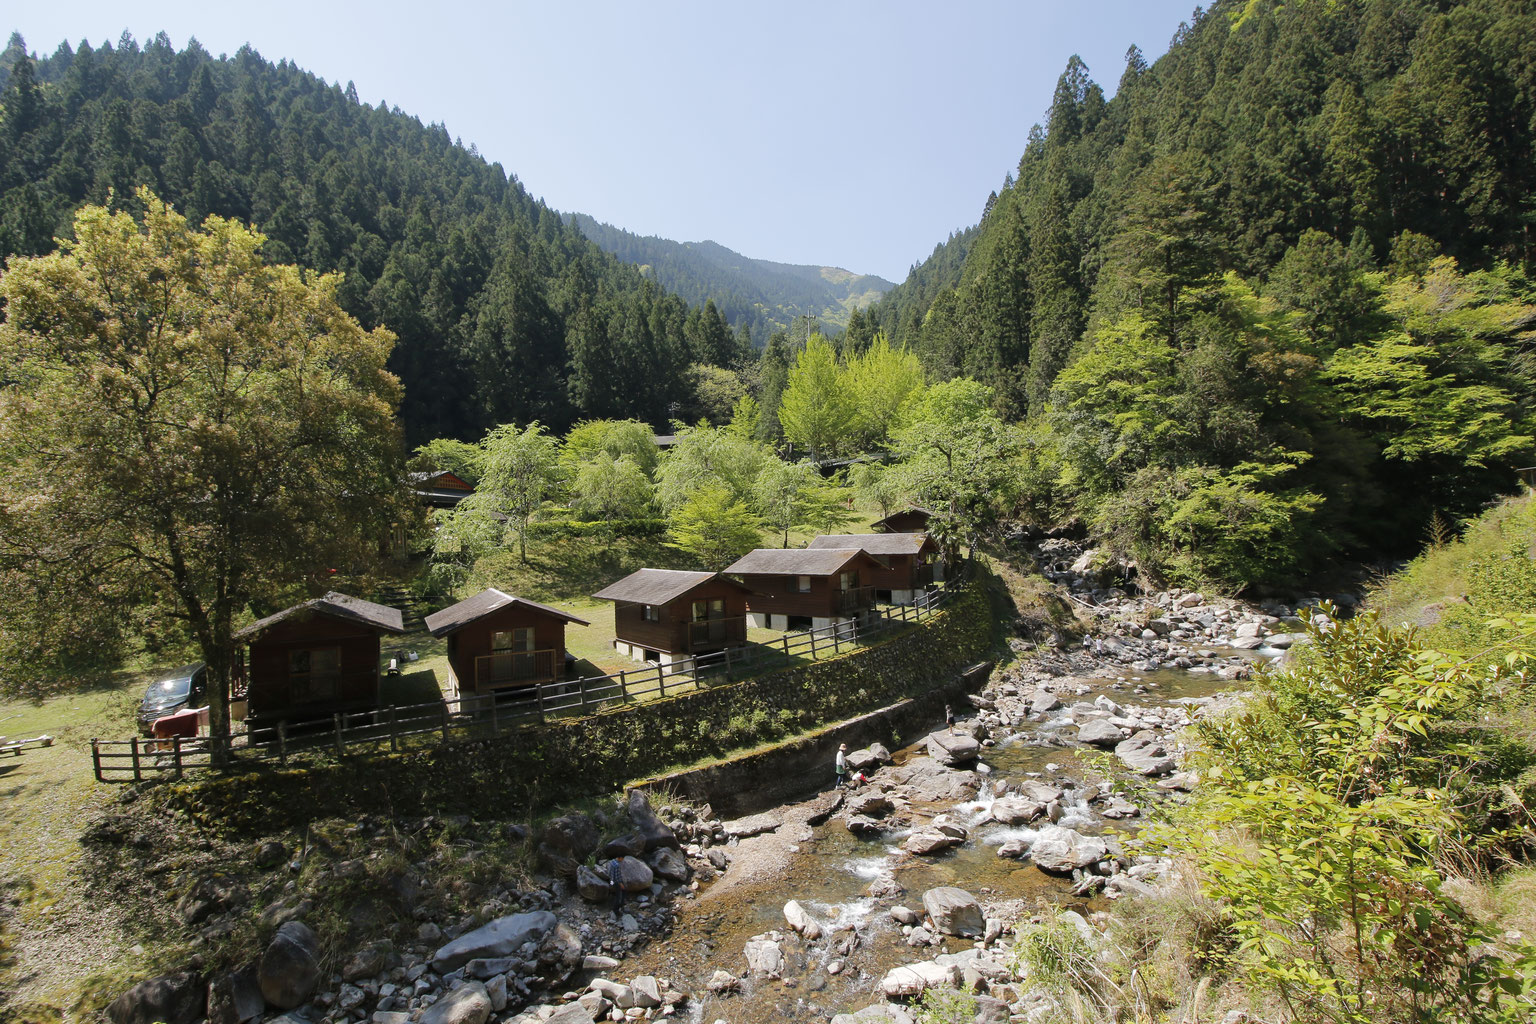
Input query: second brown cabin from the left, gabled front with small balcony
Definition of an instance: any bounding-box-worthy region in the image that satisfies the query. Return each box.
[427,588,591,694]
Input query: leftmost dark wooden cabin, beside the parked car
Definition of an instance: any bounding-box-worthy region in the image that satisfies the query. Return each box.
[235,591,406,723]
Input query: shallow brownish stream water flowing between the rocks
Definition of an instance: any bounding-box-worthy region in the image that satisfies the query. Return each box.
[621,669,1233,1024]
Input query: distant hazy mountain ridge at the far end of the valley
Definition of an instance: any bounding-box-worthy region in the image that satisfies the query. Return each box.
[565,213,895,345]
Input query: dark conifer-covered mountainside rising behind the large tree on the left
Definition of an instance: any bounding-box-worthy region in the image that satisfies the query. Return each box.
[0,34,742,441]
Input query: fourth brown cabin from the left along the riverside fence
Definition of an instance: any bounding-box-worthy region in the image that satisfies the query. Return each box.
[725,548,888,629]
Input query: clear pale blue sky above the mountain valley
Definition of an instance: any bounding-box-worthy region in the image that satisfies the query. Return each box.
[14,0,1190,281]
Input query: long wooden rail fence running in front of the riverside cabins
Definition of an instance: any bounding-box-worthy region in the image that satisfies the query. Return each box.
[91,588,949,781]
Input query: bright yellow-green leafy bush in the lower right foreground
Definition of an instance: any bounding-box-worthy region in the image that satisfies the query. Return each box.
[1158,609,1536,1024]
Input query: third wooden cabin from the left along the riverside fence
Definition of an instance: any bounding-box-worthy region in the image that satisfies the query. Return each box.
[593,570,748,665]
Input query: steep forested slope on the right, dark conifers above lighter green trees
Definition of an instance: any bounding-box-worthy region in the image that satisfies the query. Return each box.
[849,0,1536,580]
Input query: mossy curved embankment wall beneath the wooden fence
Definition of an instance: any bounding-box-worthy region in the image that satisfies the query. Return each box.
[163,576,995,834]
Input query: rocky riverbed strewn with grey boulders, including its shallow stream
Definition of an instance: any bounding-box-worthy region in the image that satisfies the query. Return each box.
[109,540,1339,1024]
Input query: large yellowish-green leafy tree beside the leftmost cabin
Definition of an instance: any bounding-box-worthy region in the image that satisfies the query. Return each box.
[0,190,407,735]
